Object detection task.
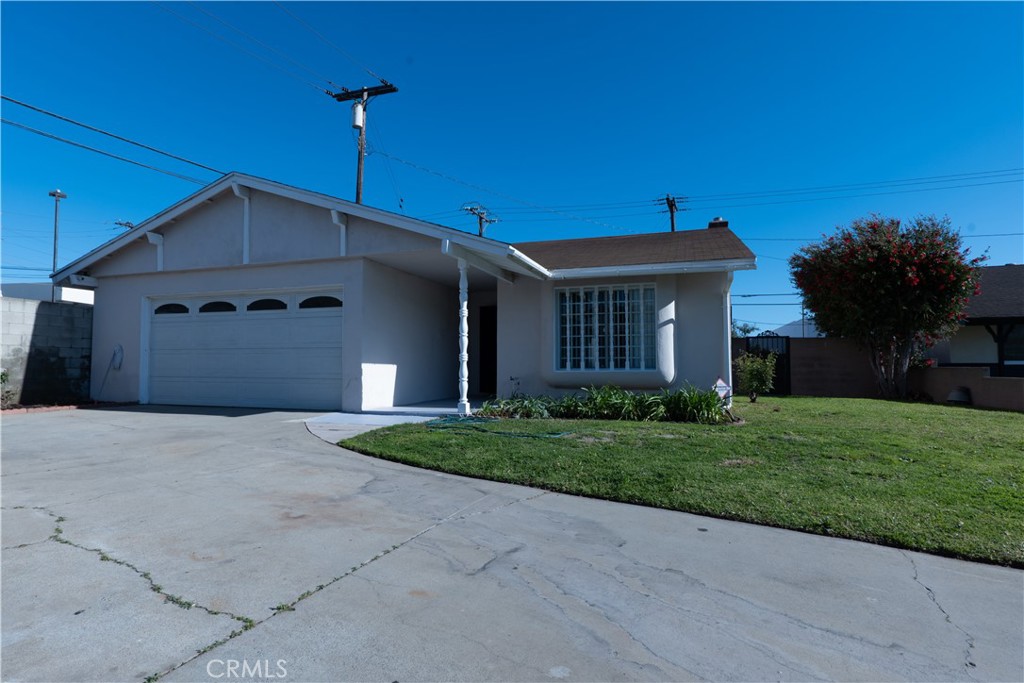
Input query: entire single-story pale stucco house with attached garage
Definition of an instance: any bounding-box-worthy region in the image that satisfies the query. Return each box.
[53,173,755,414]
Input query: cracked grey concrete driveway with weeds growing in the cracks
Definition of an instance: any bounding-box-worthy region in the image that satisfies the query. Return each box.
[0,409,1024,681]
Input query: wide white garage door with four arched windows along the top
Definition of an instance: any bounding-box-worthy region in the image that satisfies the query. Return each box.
[148,291,342,410]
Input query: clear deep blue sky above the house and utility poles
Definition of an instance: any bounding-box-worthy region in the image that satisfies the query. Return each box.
[0,1,1024,329]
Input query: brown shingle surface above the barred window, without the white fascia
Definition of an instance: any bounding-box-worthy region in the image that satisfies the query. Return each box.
[512,227,754,270]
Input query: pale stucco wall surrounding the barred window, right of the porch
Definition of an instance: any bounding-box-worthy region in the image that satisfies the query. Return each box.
[498,272,730,396]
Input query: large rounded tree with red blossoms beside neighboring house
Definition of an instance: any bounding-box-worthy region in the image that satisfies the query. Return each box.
[790,215,984,398]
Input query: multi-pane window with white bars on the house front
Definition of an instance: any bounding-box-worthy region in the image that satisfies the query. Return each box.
[553,283,658,373]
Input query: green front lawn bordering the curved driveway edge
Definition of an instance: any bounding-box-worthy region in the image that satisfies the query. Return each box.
[341,397,1024,567]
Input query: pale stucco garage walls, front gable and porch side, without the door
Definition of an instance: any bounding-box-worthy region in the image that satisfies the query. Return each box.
[83,189,468,411]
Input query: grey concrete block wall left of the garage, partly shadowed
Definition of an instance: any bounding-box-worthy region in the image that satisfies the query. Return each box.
[0,297,92,404]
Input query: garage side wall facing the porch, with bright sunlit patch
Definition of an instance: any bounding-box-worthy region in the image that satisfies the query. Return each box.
[360,260,459,410]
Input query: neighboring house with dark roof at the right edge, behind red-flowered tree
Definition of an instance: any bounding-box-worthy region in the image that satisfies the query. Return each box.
[930,265,1024,377]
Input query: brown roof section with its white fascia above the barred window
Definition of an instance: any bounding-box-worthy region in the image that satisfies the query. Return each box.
[514,227,755,278]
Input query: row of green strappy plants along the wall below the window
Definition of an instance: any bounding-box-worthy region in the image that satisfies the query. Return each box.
[477,386,731,425]
